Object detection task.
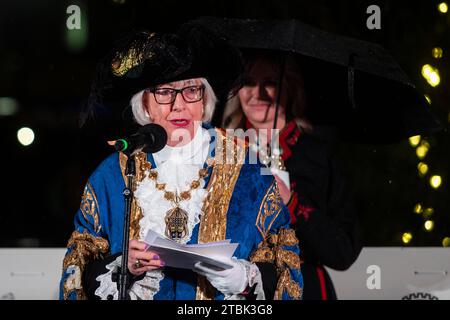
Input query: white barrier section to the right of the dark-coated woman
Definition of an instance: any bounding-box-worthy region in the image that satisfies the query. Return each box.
[327,247,450,300]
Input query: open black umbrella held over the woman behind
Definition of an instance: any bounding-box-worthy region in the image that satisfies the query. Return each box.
[197,17,442,143]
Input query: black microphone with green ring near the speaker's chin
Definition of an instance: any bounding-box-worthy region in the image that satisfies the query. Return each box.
[114,123,167,155]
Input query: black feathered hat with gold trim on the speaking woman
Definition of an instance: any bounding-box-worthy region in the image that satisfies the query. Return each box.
[80,22,243,139]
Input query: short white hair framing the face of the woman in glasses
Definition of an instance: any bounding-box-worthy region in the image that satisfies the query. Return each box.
[130,78,217,126]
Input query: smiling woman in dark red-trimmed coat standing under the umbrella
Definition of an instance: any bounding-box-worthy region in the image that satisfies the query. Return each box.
[222,50,362,300]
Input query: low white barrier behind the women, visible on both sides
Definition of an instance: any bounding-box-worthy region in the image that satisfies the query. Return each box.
[0,248,450,300]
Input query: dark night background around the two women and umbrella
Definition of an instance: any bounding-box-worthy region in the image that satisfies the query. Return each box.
[0,0,450,247]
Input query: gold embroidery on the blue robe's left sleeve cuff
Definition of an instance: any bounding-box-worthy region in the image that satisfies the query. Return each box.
[63,230,109,299]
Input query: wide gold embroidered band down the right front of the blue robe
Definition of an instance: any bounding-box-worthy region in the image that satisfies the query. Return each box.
[196,129,247,300]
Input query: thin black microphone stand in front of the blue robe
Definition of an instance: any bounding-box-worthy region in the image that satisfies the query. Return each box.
[117,153,136,300]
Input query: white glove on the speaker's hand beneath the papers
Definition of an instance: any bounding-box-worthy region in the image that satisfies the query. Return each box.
[194,258,248,295]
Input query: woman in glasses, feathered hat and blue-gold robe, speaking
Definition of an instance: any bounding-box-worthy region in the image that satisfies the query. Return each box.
[61,24,303,300]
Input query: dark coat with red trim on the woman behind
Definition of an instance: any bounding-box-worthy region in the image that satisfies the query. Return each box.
[280,121,362,300]
